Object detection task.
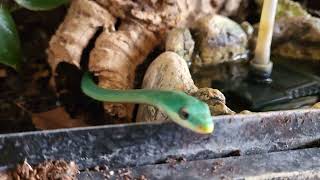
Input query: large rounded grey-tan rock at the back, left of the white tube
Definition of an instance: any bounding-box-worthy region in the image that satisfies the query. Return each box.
[192,15,248,67]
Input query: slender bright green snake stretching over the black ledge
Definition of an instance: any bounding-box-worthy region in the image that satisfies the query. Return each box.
[81,72,214,134]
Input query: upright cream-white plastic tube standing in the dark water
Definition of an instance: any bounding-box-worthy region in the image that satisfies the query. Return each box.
[251,0,278,74]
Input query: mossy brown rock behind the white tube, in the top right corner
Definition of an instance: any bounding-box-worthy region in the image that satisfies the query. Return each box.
[251,0,320,61]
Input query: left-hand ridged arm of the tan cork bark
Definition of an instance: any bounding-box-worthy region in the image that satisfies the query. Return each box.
[47,0,115,72]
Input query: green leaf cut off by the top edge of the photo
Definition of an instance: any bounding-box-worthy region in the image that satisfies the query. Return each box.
[15,0,69,11]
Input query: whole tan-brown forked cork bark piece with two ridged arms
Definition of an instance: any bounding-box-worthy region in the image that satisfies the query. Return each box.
[47,0,242,119]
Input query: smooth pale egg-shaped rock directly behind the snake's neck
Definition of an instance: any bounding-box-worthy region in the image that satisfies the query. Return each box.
[136,52,198,122]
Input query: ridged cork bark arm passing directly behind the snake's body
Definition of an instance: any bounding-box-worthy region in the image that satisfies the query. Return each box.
[89,22,159,119]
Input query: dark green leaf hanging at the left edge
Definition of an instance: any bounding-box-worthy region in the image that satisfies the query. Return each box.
[0,6,22,69]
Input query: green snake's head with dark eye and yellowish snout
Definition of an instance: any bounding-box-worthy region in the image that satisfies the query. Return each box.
[161,92,214,134]
